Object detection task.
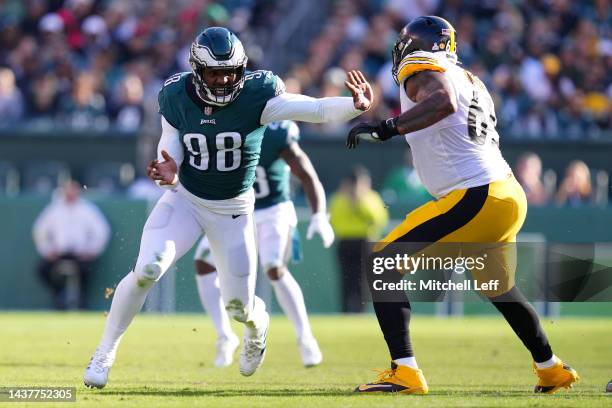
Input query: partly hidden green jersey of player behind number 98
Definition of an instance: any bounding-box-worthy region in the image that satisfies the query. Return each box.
[253,120,300,209]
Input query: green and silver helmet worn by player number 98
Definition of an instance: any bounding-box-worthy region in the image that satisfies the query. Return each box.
[189,27,248,106]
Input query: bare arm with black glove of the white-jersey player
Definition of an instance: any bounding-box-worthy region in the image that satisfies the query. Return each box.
[346,71,457,148]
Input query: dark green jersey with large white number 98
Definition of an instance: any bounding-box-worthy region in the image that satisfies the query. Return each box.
[158,71,284,200]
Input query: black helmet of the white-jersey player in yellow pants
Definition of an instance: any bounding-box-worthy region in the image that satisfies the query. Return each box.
[391,16,457,85]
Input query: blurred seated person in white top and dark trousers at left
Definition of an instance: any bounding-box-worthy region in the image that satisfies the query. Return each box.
[32,181,110,309]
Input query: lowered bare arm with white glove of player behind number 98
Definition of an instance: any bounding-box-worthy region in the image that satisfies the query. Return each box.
[280,143,335,248]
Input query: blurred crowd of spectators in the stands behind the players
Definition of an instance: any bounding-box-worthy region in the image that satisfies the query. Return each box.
[0,0,612,139]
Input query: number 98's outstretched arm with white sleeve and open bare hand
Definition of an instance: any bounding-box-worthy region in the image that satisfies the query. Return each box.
[261,71,374,124]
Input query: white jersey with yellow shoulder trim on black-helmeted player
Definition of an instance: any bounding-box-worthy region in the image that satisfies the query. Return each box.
[398,51,512,197]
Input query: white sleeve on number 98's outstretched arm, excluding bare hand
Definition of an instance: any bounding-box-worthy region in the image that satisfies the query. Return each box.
[261,93,363,125]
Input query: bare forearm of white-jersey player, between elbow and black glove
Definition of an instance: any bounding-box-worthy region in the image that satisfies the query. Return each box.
[396,90,457,135]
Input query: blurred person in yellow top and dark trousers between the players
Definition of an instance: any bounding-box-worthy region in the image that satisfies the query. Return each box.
[329,167,389,313]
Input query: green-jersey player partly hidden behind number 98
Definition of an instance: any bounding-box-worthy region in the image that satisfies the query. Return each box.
[195,121,334,367]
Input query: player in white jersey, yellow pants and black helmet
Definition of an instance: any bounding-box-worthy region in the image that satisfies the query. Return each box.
[347,16,578,394]
